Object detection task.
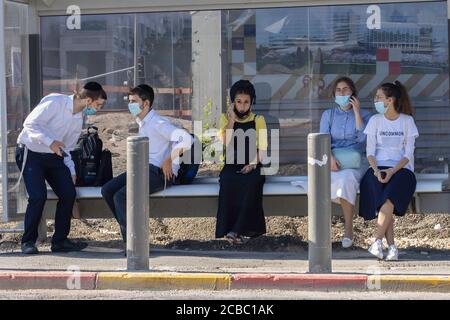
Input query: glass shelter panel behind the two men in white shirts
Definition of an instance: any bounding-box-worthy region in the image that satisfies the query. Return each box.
[41,12,192,175]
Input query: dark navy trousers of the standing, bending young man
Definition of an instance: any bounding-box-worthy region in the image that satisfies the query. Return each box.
[16,147,76,243]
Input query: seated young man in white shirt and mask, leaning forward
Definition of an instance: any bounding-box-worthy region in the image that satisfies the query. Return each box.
[102,84,192,242]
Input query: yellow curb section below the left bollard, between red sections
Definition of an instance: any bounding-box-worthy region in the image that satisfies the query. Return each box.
[96,272,231,290]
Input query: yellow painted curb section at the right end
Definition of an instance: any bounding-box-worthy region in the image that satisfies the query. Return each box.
[367,275,450,292]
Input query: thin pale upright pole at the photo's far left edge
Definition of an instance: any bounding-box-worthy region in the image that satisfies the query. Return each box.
[0,0,8,221]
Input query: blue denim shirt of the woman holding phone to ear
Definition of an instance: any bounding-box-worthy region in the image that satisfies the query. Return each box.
[320,107,372,153]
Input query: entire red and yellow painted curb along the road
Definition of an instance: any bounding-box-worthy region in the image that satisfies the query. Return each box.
[0,271,450,293]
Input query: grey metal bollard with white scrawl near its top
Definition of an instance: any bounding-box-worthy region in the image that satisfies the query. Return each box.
[308,133,331,273]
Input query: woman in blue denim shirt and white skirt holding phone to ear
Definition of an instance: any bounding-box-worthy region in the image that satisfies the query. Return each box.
[320,77,371,248]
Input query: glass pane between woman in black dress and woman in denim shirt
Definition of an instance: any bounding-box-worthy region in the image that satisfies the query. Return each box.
[226,7,314,175]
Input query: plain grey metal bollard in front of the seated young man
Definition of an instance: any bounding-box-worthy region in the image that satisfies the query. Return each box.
[127,136,150,271]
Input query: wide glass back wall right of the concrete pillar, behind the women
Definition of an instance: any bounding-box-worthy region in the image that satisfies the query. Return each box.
[224,1,450,175]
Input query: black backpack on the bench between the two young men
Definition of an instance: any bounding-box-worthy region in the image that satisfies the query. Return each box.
[70,126,112,187]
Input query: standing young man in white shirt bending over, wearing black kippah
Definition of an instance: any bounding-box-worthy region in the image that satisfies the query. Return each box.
[16,82,106,254]
